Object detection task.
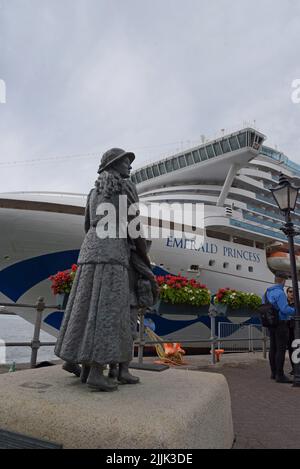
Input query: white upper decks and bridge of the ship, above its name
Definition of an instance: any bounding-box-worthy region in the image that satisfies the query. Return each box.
[132,128,300,244]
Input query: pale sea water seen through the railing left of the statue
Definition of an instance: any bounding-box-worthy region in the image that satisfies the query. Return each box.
[0,314,58,364]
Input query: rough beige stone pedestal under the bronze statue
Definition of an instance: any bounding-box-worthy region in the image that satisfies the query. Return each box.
[0,366,233,449]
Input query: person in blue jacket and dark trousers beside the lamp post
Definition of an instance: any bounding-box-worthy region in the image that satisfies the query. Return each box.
[263,272,295,383]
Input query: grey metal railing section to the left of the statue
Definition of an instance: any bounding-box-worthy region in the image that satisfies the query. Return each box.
[0,297,61,368]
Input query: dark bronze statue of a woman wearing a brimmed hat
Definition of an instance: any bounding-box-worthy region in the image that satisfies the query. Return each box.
[55,148,155,391]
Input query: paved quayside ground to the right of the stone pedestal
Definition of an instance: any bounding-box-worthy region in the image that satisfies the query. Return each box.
[0,353,300,449]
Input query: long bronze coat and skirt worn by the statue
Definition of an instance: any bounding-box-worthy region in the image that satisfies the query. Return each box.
[55,171,133,365]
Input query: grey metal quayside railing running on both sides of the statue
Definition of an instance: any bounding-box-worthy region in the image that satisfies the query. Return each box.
[0,297,268,368]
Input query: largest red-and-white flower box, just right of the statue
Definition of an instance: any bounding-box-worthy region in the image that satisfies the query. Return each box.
[156,274,211,306]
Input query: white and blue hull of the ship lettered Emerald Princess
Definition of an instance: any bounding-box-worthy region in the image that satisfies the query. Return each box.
[0,203,272,345]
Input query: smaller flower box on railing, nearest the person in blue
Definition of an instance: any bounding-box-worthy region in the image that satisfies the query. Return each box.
[214,288,261,310]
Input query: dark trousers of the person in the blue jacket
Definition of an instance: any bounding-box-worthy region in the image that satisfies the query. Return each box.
[269,321,289,378]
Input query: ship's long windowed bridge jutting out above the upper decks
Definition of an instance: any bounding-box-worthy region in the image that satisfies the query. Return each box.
[132,128,266,194]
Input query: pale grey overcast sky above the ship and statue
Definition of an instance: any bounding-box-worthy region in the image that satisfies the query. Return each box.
[0,0,300,192]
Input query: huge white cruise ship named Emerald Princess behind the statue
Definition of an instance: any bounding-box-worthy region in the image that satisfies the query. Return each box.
[0,128,300,340]
